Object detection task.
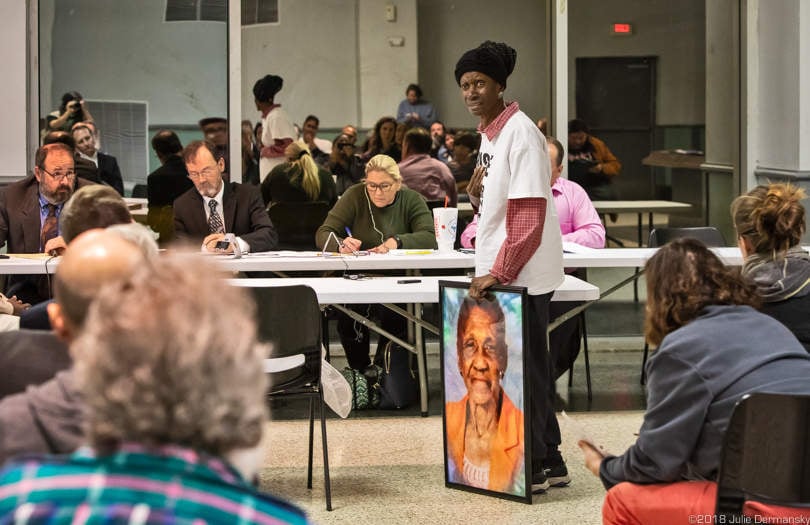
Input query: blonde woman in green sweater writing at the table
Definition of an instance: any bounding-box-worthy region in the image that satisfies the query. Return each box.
[315,155,436,371]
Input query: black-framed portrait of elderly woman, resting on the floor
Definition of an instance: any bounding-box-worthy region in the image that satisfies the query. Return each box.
[439,281,532,503]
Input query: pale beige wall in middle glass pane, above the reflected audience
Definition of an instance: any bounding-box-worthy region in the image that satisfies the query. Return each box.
[242,0,418,128]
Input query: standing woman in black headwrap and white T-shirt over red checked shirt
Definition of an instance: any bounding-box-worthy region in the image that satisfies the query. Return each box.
[455,41,570,493]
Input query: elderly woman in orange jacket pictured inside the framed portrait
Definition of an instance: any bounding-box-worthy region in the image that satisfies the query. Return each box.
[445,297,525,494]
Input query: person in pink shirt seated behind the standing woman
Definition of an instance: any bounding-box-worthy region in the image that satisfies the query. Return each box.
[461,137,605,379]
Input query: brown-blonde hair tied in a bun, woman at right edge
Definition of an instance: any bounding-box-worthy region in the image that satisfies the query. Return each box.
[731,183,805,257]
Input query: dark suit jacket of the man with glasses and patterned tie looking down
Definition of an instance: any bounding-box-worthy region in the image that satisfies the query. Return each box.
[174,181,278,252]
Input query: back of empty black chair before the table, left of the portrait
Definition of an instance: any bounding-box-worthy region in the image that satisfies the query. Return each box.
[250,285,321,394]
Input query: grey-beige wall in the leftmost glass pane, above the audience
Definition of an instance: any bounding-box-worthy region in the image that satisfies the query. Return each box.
[40,0,227,125]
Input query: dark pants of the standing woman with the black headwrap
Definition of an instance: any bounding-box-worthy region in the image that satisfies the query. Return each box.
[524,292,562,473]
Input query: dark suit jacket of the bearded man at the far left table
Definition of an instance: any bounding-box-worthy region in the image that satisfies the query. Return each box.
[0,175,93,304]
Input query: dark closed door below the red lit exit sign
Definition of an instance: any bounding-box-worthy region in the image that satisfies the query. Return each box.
[576,56,657,200]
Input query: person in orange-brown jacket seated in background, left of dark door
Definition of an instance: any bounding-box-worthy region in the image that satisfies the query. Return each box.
[568,119,622,201]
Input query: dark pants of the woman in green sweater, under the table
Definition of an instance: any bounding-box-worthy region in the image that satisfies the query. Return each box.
[337,304,408,372]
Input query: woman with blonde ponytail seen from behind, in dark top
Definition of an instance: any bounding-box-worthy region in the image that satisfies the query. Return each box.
[262,142,337,207]
